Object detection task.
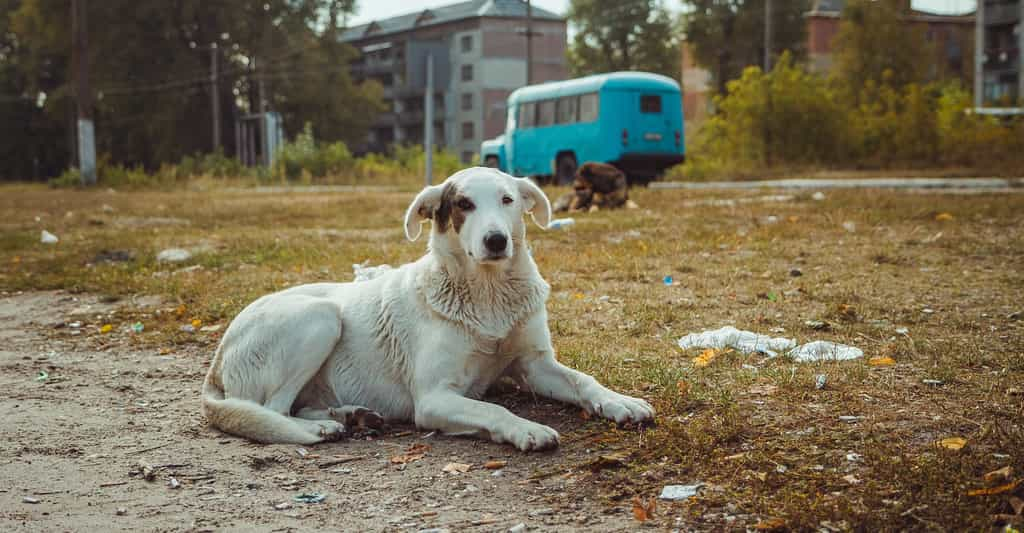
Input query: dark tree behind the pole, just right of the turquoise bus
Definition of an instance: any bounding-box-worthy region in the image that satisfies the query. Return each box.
[682,0,811,94]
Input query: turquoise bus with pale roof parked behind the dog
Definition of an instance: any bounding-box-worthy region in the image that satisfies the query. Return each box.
[480,72,686,184]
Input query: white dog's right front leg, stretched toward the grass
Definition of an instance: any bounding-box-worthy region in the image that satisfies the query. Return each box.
[511,312,654,424]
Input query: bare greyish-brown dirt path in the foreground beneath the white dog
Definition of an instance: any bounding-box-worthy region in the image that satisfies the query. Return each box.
[0,293,643,531]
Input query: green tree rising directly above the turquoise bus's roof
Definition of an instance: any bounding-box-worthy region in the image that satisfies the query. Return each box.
[568,0,680,78]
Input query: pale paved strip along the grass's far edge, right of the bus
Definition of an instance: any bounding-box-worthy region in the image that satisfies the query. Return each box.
[650,178,1024,190]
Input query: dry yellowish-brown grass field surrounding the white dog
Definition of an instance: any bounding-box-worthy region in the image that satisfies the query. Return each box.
[0,182,1024,530]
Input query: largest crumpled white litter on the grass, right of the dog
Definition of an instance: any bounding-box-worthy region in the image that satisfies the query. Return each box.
[678,325,864,363]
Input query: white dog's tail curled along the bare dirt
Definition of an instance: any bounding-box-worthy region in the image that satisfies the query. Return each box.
[202,349,323,444]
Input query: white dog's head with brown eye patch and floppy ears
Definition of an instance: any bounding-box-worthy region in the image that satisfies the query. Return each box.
[406,167,551,263]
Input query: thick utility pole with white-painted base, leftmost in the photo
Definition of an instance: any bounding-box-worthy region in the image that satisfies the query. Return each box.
[71,0,96,186]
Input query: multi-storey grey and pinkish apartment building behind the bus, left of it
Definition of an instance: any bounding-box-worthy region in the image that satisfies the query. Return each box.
[342,0,568,162]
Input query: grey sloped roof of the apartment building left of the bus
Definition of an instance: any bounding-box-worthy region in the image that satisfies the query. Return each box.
[341,0,565,41]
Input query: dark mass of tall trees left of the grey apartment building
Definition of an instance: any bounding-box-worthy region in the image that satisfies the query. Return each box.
[0,0,382,179]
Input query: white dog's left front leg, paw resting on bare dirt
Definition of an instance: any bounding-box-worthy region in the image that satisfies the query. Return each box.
[416,385,558,451]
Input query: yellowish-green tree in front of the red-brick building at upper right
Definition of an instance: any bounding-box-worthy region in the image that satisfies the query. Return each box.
[834,0,935,97]
